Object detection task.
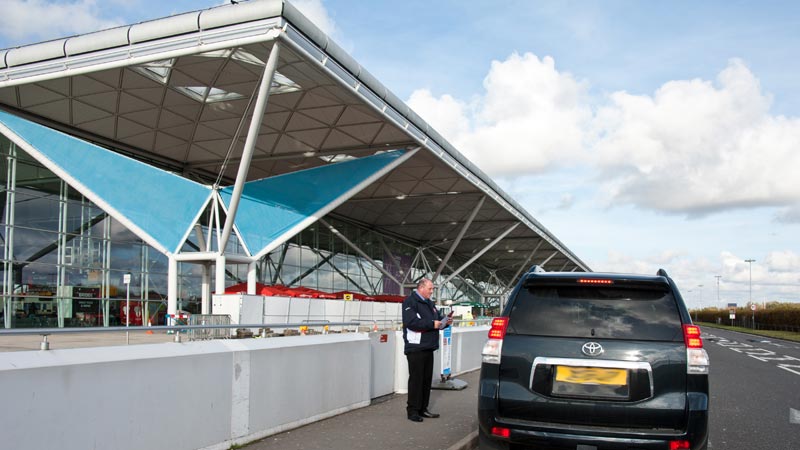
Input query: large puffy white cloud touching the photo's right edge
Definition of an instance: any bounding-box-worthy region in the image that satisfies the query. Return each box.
[593,60,800,215]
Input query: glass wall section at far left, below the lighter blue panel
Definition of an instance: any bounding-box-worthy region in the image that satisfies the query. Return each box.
[0,136,180,328]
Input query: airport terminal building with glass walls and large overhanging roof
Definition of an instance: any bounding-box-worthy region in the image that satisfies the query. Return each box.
[0,0,589,328]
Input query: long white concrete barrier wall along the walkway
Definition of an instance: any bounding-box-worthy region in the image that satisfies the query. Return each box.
[0,326,487,450]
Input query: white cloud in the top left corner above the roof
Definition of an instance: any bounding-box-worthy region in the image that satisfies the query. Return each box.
[0,0,123,43]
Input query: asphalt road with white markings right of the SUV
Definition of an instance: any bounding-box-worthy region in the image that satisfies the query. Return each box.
[703,327,800,450]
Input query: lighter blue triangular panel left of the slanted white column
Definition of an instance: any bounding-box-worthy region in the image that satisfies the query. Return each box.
[0,111,212,253]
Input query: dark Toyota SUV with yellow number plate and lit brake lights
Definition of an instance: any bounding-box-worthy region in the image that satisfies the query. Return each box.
[478,267,709,450]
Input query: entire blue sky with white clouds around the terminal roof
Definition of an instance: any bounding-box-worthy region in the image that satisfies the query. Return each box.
[0,0,800,307]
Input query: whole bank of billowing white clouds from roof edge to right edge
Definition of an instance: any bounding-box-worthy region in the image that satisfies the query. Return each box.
[408,53,800,223]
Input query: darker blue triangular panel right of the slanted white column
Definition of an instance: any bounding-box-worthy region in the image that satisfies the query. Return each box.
[220,150,406,256]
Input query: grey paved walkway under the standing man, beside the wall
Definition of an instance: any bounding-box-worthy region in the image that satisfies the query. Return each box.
[241,370,480,450]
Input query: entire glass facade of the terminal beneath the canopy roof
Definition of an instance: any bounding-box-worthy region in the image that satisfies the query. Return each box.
[0,135,494,328]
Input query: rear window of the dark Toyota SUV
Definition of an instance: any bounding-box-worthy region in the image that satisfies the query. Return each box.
[508,285,683,341]
